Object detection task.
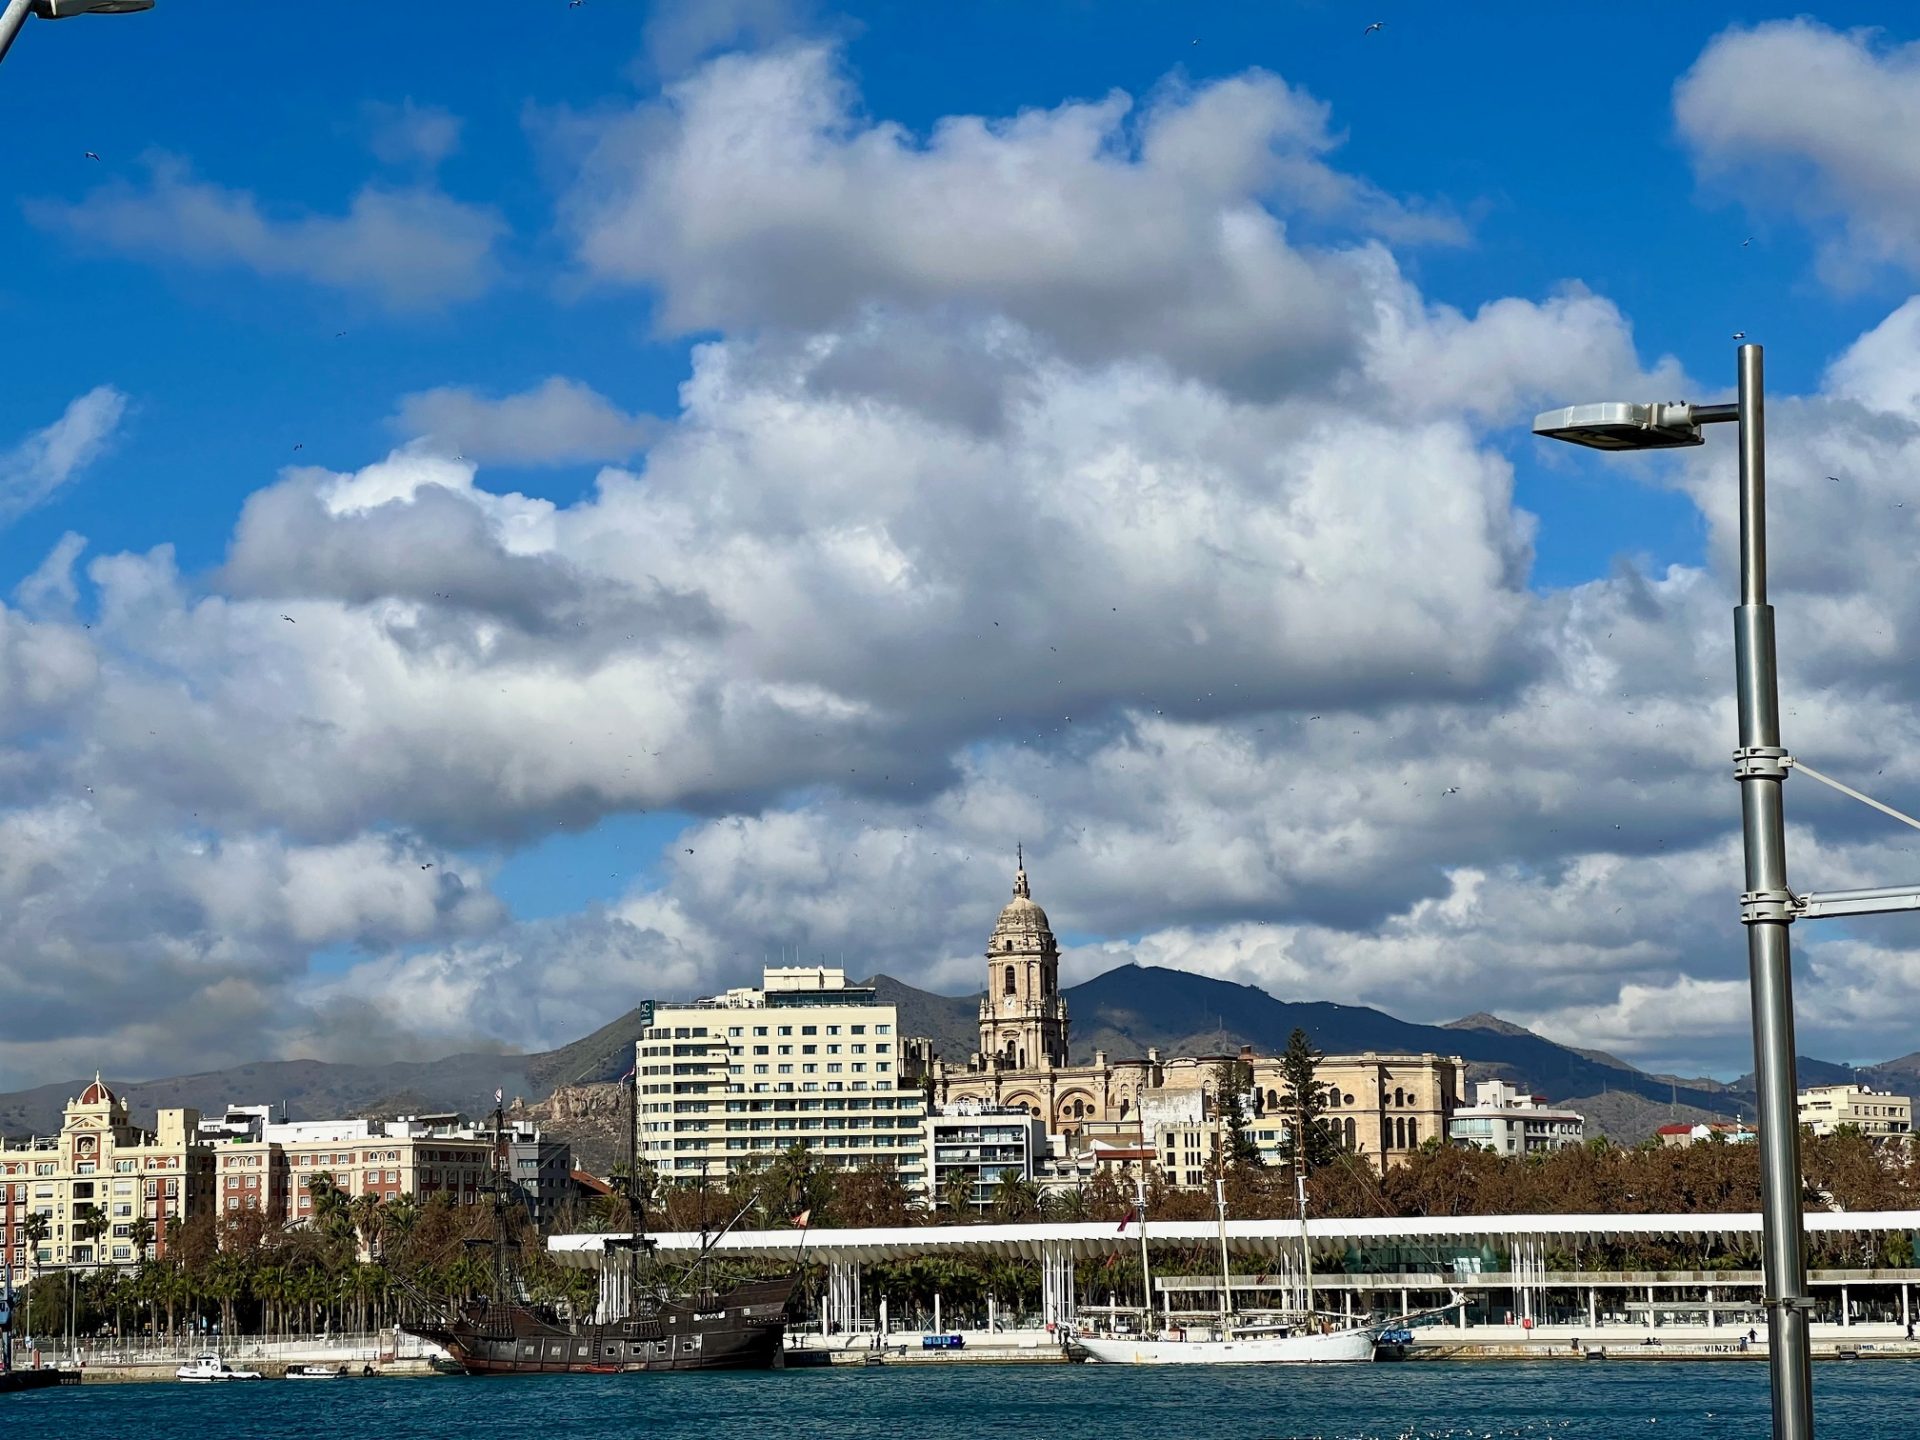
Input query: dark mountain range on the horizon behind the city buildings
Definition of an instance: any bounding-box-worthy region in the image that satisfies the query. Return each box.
[0,966,1920,1139]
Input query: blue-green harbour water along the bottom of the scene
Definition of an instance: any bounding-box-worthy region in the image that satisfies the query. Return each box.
[0,1361,1920,1440]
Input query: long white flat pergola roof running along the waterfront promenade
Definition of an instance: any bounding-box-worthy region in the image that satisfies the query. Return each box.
[547,1210,1920,1269]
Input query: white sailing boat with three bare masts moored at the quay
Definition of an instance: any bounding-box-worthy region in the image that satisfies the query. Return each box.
[1075,1175,1382,1365]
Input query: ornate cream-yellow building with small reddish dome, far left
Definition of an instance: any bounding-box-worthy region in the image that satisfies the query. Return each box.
[0,1075,215,1273]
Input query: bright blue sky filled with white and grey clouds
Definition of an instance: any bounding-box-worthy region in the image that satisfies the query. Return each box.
[0,0,1920,1087]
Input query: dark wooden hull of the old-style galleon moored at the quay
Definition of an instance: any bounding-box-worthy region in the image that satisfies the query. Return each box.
[407,1275,795,1375]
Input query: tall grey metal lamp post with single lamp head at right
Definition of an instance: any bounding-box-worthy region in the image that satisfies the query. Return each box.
[1534,344,1812,1440]
